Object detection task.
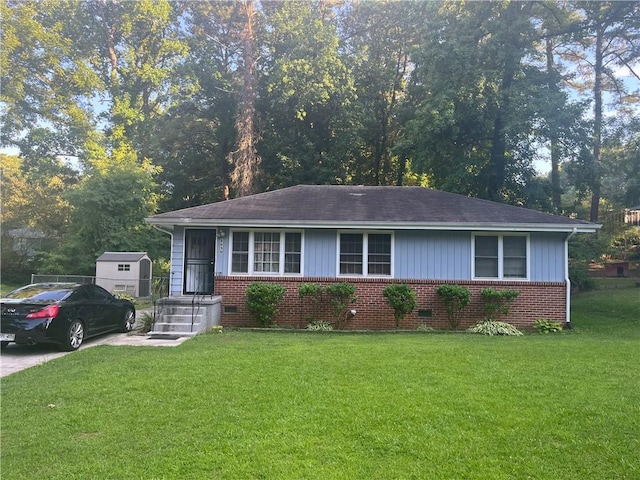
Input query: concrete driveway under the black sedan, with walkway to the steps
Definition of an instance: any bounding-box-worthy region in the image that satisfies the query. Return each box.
[0,333,189,377]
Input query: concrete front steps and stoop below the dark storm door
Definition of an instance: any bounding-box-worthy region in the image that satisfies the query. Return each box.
[148,296,222,338]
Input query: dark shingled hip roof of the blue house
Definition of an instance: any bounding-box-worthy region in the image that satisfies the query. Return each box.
[148,185,598,229]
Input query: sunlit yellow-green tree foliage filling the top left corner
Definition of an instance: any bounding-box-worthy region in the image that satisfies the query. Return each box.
[0,0,100,155]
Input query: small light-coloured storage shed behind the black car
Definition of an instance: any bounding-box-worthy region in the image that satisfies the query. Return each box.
[96,252,151,297]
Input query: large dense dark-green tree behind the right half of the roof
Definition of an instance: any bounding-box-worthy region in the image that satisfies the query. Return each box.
[404,1,540,202]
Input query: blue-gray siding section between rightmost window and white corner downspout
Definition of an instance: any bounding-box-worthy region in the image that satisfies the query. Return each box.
[529,233,566,282]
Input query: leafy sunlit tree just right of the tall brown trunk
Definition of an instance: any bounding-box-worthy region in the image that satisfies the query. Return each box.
[258,0,354,188]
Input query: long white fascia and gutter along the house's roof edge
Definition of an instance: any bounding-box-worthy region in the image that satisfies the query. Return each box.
[145,218,602,233]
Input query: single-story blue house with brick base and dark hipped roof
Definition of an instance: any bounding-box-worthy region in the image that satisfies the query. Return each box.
[147,185,600,329]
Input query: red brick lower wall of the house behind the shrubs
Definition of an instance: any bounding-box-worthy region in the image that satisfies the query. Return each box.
[215,276,566,330]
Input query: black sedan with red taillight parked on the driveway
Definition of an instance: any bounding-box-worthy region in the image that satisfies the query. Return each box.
[0,283,136,350]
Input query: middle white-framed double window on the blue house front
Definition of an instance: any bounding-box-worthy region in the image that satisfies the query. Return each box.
[338,233,391,276]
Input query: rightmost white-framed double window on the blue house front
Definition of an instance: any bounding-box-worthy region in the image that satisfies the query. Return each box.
[473,235,529,279]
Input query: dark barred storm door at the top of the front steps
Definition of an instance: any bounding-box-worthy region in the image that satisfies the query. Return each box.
[184,230,216,295]
